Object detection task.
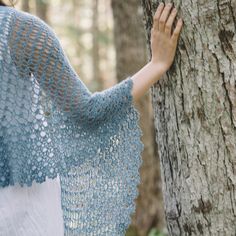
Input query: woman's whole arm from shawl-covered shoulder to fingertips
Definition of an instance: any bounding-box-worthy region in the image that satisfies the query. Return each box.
[8,4,183,125]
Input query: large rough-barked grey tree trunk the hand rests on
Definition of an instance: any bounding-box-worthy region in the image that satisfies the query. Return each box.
[142,0,236,236]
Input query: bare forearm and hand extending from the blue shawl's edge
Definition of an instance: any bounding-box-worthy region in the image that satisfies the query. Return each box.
[131,3,183,101]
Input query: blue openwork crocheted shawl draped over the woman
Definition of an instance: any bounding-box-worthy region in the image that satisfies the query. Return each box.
[0,7,144,236]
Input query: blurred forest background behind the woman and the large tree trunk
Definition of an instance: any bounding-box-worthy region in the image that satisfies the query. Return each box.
[15,0,167,236]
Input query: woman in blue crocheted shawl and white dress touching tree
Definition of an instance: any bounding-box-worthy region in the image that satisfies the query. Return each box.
[0,1,183,236]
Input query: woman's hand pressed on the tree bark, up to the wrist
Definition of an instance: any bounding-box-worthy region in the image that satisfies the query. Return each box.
[151,3,183,73]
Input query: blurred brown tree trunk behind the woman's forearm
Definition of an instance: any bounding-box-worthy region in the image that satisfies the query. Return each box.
[112,0,164,236]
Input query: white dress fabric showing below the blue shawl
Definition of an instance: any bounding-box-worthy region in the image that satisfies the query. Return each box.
[0,177,64,236]
